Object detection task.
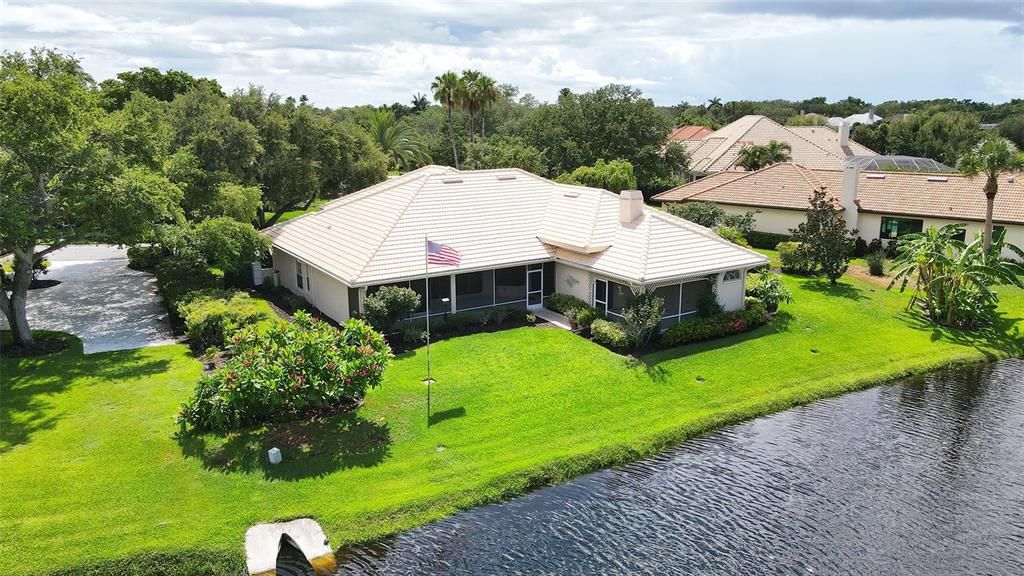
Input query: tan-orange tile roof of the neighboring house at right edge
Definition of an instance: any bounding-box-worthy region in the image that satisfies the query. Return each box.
[653,162,1024,224]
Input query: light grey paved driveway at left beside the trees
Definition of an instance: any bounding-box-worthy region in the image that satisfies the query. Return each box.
[3,245,175,354]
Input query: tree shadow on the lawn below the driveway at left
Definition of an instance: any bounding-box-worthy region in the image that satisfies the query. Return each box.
[0,332,170,453]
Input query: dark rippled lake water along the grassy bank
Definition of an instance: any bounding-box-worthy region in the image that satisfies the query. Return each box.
[339,360,1024,575]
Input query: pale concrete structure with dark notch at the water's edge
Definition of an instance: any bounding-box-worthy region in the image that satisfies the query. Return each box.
[246,518,335,576]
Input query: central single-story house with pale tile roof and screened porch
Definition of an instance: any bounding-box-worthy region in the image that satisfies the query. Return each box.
[265,166,768,324]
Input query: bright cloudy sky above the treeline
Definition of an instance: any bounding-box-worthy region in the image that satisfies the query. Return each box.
[0,0,1024,107]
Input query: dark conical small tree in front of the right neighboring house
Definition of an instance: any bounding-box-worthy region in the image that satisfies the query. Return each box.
[793,189,857,284]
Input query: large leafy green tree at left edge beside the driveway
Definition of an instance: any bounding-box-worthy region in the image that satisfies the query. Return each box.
[0,49,182,346]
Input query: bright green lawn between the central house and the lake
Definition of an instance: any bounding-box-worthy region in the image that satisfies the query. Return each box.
[0,277,1024,575]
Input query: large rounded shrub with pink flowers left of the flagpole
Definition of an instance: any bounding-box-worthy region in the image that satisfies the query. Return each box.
[178,312,392,430]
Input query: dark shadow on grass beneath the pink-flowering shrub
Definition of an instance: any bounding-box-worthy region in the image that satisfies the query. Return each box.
[176,412,391,480]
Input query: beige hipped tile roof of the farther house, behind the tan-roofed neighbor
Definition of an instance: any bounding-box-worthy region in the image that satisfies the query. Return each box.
[679,115,874,174]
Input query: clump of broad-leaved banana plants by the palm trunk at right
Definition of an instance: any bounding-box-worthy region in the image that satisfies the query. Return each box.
[889,224,1024,328]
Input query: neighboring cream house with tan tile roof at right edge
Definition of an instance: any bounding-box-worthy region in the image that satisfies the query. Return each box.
[653,159,1024,256]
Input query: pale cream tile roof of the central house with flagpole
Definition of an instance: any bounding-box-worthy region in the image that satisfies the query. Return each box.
[264,166,767,286]
